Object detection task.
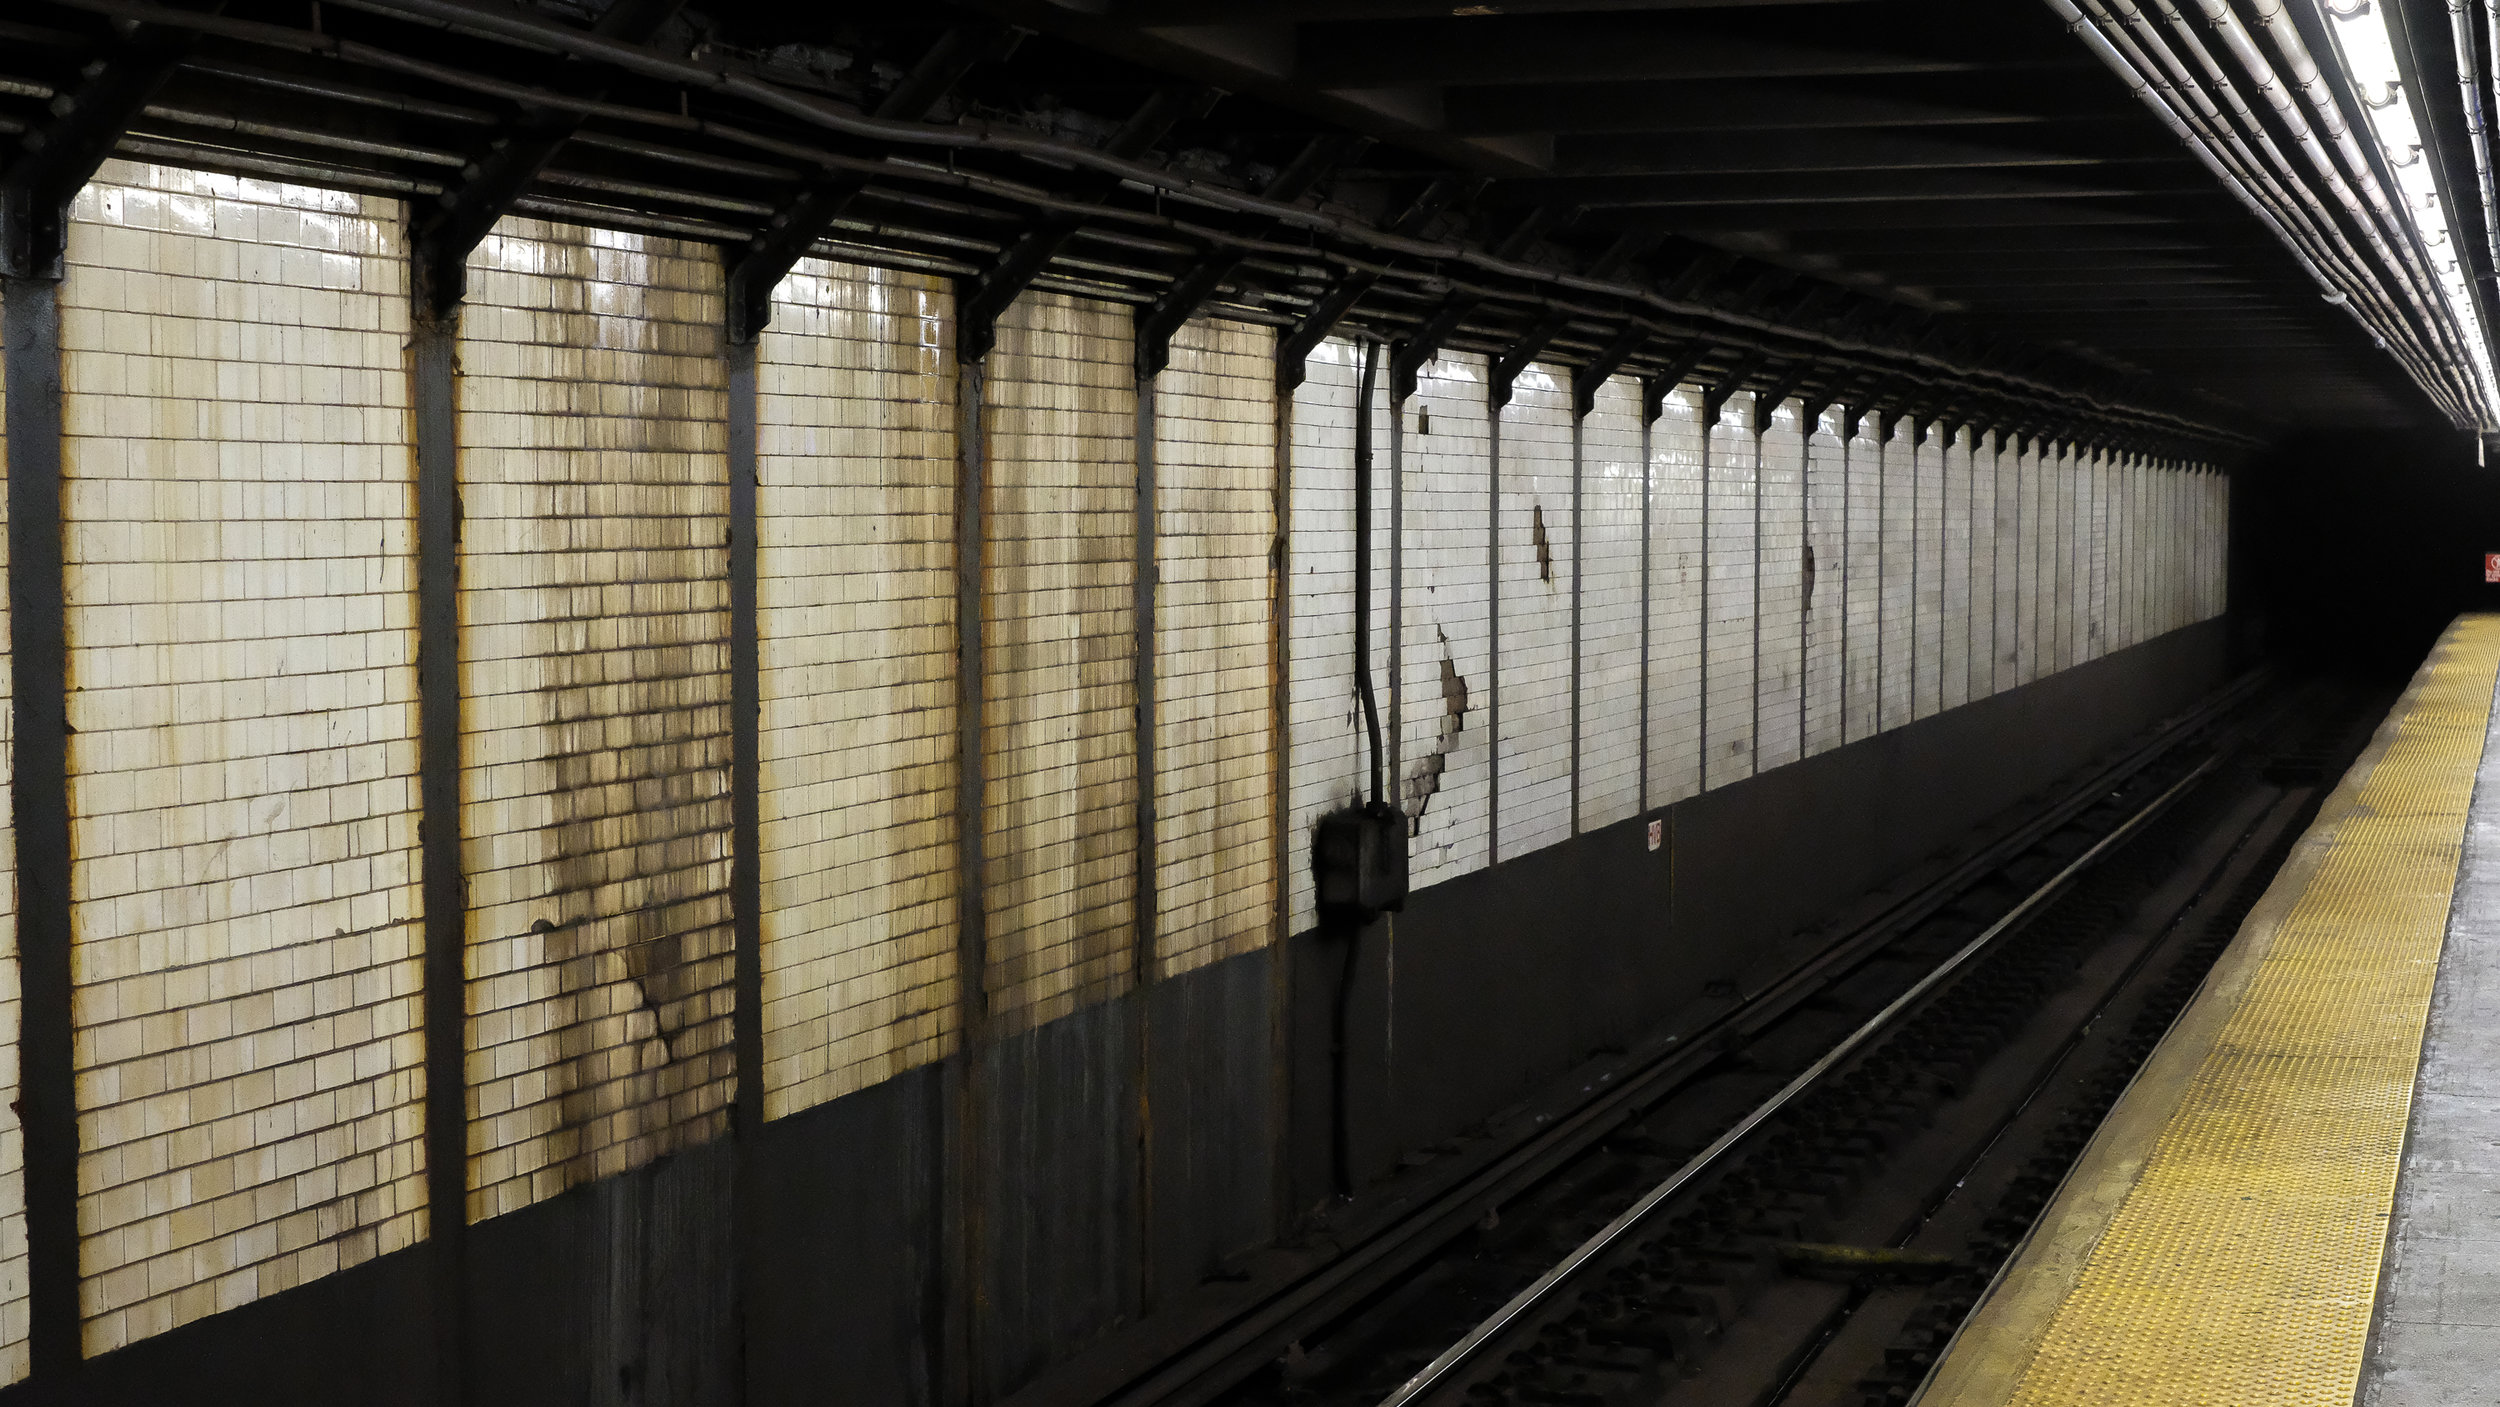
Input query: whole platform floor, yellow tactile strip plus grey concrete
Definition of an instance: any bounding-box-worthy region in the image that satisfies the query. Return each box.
[1918,615,2500,1407]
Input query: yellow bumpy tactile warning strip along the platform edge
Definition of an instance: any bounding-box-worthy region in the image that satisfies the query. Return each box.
[1920,615,2500,1407]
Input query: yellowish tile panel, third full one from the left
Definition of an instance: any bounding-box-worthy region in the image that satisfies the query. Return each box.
[755,260,960,1117]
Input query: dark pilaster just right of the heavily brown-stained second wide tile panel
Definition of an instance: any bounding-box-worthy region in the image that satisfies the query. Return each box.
[725,340,765,1362]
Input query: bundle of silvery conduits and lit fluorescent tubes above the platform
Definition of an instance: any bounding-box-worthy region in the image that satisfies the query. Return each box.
[2048,0,2500,432]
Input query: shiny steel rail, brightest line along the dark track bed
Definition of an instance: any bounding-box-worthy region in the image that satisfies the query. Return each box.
[1380,757,2220,1407]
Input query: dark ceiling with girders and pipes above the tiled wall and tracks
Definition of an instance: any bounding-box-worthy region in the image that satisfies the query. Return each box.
[0,0,2480,445]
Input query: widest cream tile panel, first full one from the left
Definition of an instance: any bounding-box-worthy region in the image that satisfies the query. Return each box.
[57,162,425,1352]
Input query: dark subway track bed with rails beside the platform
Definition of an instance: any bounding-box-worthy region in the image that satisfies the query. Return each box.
[1050,680,2388,1407]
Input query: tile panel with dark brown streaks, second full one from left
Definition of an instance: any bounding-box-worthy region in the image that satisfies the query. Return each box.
[460,220,733,1217]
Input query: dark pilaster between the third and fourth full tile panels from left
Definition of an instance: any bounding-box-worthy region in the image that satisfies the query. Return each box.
[938,357,990,1402]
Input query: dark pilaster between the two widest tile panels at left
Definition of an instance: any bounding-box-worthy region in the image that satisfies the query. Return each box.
[410,307,468,1405]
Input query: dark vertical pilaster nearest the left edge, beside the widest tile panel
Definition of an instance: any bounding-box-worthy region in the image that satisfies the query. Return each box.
[0,277,80,1382]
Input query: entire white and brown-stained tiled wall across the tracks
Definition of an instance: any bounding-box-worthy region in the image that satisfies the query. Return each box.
[0,165,2228,1382]
